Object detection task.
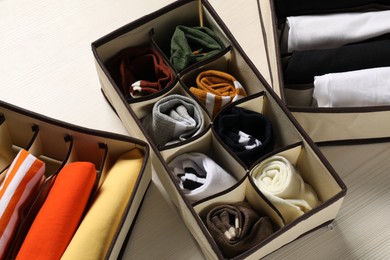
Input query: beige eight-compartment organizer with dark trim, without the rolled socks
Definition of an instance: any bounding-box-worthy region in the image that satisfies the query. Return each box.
[92,1,346,259]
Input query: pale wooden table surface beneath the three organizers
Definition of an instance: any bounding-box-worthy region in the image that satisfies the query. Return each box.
[0,0,390,259]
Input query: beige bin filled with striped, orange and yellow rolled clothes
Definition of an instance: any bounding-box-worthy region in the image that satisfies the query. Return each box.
[0,102,151,259]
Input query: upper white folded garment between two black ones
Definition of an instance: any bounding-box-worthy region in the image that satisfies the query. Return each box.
[287,10,390,52]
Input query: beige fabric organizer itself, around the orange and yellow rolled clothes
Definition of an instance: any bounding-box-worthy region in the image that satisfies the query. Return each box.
[0,101,151,259]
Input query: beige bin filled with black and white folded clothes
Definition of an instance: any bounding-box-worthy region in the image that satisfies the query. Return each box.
[258,0,390,142]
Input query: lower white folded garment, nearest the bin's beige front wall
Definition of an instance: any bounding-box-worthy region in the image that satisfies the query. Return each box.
[313,67,390,107]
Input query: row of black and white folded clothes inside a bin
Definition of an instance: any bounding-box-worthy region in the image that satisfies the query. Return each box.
[276,7,390,107]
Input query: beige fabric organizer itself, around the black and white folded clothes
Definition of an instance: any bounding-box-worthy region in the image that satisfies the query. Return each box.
[258,0,390,142]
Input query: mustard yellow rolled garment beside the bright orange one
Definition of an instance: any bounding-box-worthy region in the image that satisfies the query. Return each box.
[61,149,144,260]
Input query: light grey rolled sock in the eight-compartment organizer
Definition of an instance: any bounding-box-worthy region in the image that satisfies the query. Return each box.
[142,94,205,147]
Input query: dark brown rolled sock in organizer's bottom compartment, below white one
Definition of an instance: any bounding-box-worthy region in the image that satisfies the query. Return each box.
[205,202,274,259]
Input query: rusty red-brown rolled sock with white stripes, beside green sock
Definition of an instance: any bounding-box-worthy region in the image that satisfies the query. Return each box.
[106,47,174,100]
